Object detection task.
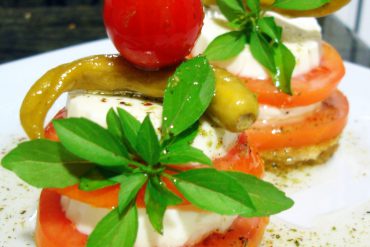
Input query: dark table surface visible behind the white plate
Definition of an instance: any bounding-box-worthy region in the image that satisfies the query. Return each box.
[0,0,370,67]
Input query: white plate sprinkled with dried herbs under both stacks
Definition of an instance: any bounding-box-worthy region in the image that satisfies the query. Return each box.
[0,40,370,246]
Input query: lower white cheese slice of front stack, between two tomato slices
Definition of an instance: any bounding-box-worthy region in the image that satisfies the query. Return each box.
[61,196,237,247]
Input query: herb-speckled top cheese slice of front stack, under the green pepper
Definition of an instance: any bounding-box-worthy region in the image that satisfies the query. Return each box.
[67,91,238,159]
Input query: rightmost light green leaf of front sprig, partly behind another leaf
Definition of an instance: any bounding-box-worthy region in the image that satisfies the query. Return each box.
[224,171,294,217]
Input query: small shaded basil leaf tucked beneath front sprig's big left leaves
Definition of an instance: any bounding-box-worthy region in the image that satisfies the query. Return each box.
[78,167,117,191]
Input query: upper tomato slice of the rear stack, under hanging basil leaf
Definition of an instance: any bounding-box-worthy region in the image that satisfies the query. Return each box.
[244,43,345,107]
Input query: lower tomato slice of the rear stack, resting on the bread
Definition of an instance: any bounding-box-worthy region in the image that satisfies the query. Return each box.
[246,90,349,151]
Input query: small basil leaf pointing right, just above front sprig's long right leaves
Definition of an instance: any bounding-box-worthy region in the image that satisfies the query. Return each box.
[159,145,212,166]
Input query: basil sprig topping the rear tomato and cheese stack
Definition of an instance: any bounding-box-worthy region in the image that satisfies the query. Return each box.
[204,0,330,95]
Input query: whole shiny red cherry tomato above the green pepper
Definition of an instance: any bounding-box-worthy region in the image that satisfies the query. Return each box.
[104,0,204,70]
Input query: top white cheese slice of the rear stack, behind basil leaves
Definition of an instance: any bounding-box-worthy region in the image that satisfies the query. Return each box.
[192,12,322,79]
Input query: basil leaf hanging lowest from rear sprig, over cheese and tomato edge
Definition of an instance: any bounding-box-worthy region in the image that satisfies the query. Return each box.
[273,43,296,95]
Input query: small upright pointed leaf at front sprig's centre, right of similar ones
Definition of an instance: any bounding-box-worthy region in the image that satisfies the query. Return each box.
[135,115,161,165]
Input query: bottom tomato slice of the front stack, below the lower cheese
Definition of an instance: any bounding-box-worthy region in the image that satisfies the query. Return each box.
[35,189,268,247]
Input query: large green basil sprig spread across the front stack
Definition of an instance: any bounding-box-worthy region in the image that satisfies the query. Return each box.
[2,56,293,247]
